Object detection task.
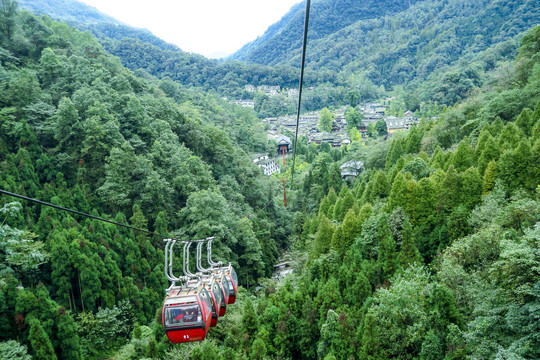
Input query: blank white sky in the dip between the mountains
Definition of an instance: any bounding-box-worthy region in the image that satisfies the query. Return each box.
[80,0,302,57]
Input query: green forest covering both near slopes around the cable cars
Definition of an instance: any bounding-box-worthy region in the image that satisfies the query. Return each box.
[0,0,540,360]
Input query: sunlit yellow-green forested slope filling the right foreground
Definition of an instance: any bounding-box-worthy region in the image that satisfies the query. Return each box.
[221,26,540,360]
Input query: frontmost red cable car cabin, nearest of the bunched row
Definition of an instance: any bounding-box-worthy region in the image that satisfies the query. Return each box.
[162,286,212,343]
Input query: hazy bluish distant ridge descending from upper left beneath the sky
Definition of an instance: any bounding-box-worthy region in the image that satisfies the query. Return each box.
[16,0,310,96]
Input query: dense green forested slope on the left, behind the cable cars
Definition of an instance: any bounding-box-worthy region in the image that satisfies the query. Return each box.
[0,1,290,359]
